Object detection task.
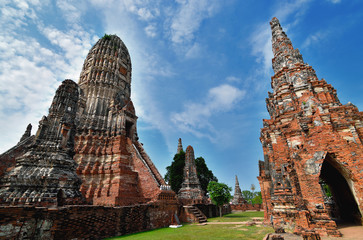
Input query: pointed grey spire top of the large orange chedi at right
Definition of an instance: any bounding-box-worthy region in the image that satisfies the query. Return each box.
[270,17,304,73]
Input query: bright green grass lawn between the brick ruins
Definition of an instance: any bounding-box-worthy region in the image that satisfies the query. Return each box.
[108,212,273,240]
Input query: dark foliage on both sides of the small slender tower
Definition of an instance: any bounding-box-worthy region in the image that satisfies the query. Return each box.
[165,151,218,193]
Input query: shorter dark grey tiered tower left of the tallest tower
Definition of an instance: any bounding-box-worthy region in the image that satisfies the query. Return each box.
[0,80,83,206]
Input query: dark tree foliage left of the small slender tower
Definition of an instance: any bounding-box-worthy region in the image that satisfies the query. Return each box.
[165,151,185,193]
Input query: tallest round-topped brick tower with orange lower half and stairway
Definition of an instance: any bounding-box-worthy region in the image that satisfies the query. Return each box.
[74,35,165,205]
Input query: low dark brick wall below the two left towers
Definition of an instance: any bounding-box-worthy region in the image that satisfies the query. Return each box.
[0,202,178,240]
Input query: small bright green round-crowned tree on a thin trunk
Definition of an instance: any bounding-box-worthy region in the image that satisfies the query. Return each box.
[207,181,232,217]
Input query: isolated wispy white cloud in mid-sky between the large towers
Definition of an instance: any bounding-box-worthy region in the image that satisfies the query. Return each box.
[171,84,246,140]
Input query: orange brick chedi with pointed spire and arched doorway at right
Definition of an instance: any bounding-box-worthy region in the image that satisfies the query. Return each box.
[258,18,363,238]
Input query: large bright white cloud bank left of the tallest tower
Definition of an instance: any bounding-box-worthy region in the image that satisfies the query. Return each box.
[0,1,94,152]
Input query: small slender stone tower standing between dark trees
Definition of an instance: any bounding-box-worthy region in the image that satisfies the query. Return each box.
[178,145,204,205]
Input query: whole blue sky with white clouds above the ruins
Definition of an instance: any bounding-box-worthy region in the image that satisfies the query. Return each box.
[0,0,363,190]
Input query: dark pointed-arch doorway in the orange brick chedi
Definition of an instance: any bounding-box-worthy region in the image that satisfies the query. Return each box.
[320,154,362,225]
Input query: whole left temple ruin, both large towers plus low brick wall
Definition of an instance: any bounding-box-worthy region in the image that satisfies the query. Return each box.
[0,35,179,239]
